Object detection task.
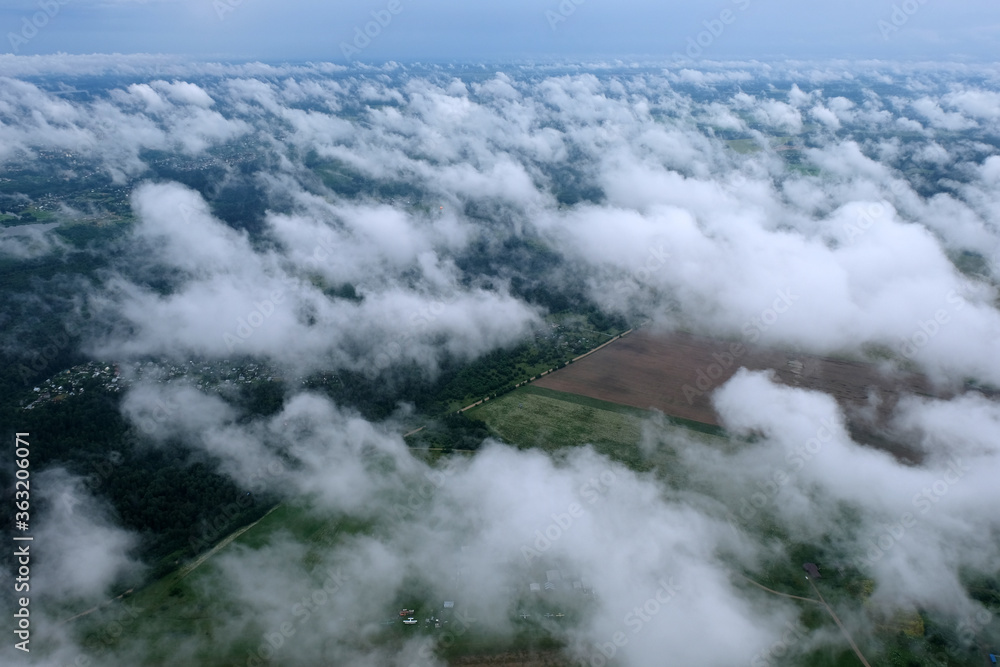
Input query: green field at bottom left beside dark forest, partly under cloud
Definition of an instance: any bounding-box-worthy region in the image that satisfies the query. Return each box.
[66,504,576,667]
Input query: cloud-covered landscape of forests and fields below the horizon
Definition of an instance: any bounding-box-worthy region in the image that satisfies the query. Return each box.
[0,56,1000,667]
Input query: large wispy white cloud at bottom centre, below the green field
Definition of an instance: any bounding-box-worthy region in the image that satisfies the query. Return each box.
[107,384,804,665]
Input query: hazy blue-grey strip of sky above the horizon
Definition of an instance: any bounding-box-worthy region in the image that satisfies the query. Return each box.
[0,0,1000,64]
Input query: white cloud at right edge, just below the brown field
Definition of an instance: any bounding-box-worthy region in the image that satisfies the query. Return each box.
[704,371,1000,614]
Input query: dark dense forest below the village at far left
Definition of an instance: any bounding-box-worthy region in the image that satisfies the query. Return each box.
[0,380,275,574]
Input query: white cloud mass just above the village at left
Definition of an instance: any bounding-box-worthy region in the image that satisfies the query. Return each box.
[83,184,537,372]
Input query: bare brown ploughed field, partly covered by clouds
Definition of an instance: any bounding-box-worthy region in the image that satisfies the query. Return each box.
[533,330,938,446]
